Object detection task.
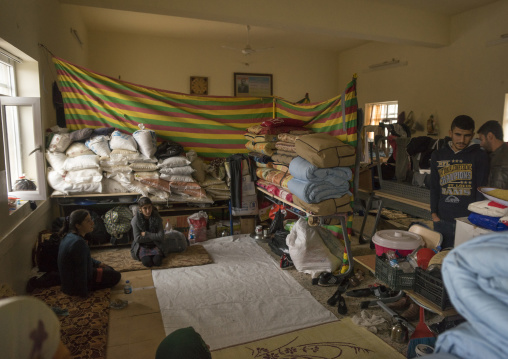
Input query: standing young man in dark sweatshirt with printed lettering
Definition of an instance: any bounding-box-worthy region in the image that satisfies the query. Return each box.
[430,115,489,248]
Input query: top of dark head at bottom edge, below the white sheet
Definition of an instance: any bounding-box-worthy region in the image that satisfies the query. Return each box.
[155,327,212,359]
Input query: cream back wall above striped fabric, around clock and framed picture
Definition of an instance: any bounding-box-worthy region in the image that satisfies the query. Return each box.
[88,31,342,102]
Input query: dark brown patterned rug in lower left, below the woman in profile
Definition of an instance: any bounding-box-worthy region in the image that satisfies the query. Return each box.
[32,286,111,359]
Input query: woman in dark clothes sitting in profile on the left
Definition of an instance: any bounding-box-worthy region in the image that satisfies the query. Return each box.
[58,209,122,297]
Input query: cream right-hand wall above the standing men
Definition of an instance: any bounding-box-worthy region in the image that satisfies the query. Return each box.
[338,1,508,137]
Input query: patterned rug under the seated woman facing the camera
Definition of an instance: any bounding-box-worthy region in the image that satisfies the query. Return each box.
[92,244,213,272]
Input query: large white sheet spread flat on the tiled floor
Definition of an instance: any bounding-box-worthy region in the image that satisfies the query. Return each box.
[152,235,337,350]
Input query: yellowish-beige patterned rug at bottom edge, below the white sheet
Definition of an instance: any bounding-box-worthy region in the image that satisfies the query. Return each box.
[212,318,405,359]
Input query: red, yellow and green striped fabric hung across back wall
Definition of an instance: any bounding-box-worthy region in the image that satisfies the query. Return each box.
[53,57,357,159]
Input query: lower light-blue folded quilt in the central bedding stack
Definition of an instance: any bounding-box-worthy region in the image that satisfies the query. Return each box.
[288,178,350,203]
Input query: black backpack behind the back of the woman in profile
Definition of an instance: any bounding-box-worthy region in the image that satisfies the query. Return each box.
[32,230,60,272]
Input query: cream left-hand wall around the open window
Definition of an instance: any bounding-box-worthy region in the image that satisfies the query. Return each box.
[0,0,86,294]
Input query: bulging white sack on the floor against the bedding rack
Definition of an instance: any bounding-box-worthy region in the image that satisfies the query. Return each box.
[286,218,341,278]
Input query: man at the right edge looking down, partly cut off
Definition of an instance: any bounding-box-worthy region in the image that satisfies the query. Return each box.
[478,121,508,189]
